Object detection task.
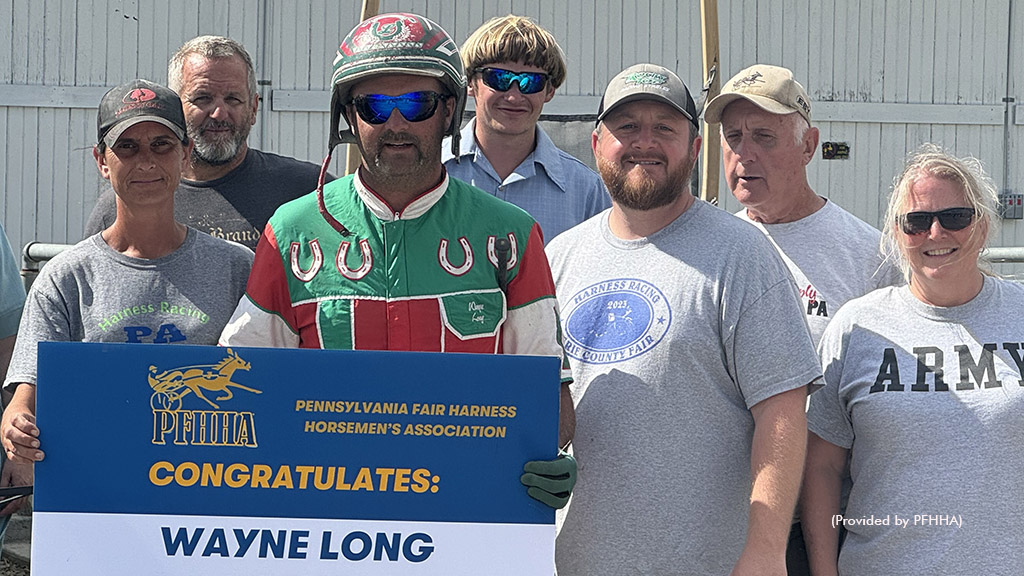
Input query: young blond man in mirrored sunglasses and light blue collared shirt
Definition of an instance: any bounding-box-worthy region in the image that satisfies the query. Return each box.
[442,14,611,242]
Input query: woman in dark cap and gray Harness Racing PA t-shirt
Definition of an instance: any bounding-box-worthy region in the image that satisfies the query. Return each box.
[0,80,253,500]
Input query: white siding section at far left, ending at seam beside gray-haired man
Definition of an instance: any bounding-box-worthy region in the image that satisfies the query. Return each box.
[0,0,260,250]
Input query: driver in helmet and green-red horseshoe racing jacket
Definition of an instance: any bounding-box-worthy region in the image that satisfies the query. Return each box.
[220,13,575,507]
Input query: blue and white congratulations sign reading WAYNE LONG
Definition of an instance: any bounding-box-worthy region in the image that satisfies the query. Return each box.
[32,343,559,576]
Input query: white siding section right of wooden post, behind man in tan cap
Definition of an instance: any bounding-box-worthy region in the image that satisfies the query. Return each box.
[720,0,1016,226]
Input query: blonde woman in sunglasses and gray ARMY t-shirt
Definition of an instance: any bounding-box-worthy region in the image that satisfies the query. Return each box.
[801,146,1024,575]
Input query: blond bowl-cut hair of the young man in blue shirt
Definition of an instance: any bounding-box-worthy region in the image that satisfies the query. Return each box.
[460,14,565,88]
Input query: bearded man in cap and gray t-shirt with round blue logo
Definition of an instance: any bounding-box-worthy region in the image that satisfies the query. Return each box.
[547,64,820,576]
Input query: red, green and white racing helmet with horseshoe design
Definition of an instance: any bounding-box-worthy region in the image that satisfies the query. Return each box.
[329,13,466,158]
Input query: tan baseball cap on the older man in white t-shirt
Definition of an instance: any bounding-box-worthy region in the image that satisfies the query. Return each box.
[703,64,811,124]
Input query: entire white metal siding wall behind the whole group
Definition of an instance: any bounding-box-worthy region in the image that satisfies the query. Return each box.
[0,0,1024,264]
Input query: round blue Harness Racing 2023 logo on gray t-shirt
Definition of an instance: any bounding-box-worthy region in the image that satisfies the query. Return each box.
[562,278,672,364]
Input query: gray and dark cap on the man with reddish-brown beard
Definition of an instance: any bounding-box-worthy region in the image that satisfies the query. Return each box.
[597,64,697,126]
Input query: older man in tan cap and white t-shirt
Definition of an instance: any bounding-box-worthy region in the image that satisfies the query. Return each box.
[705,64,900,576]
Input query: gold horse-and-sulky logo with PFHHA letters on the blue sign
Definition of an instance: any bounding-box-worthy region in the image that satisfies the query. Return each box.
[148,348,262,448]
